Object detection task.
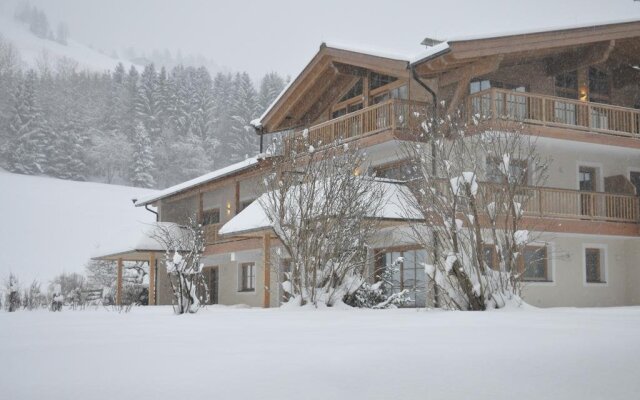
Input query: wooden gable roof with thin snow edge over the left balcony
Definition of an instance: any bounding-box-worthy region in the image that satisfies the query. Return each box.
[251,43,409,133]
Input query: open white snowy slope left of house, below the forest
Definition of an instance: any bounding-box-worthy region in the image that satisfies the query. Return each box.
[0,170,155,283]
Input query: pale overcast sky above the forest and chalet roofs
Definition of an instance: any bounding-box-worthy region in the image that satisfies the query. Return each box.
[0,0,640,77]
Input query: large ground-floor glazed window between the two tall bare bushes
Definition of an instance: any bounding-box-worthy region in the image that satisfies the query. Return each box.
[376,249,427,307]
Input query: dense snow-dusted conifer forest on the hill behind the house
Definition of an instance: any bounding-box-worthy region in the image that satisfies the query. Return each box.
[0,37,286,188]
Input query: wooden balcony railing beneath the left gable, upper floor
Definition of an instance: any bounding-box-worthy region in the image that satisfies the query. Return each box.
[284,99,427,152]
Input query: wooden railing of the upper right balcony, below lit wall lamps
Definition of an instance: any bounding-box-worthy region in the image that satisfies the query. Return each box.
[467,88,640,139]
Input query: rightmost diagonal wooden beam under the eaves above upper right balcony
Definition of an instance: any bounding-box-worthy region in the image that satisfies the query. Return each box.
[546,40,616,76]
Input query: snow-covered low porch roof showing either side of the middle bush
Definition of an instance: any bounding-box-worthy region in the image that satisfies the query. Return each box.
[218,178,422,235]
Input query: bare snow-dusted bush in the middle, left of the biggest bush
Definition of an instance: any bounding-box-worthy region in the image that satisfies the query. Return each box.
[258,136,383,307]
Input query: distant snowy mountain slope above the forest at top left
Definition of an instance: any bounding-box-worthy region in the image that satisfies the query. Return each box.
[0,15,132,72]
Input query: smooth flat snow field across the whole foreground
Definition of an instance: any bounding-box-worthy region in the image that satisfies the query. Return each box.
[0,307,640,400]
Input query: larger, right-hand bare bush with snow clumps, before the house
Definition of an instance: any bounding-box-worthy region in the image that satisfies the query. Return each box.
[404,110,548,310]
